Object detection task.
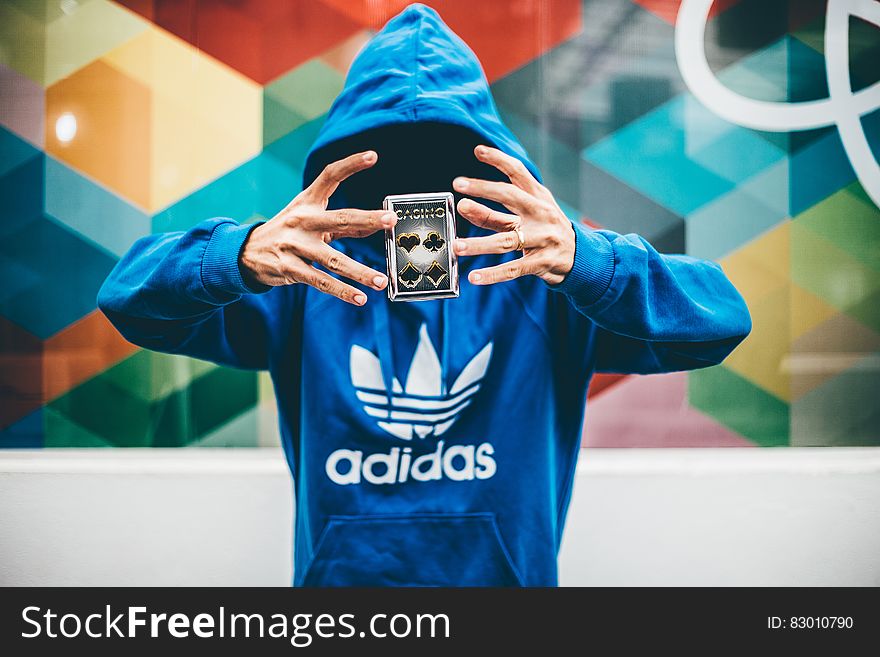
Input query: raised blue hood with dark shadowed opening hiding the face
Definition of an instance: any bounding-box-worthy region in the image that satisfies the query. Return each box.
[303,4,539,258]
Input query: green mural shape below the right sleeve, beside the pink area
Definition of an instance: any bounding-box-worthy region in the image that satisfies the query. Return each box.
[688,367,789,447]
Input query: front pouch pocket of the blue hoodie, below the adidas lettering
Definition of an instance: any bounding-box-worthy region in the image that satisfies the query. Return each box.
[298,513,523,586]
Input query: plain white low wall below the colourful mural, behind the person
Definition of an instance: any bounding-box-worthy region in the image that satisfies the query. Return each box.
[0,448,880,586]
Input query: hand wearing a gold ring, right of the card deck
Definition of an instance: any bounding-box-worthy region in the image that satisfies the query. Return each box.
[452,146,575,285]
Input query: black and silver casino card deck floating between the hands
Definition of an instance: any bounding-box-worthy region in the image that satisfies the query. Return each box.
[382,192,458,301]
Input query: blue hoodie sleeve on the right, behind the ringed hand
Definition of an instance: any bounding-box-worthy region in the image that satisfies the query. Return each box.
[550,224,752,374]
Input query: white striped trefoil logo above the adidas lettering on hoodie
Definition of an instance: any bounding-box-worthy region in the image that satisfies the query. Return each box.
[350,324,492,440]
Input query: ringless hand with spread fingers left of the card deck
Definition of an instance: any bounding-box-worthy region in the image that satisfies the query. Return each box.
[239,151,397,306]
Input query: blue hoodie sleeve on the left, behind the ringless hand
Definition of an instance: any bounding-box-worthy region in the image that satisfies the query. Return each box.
[98,219,286,369]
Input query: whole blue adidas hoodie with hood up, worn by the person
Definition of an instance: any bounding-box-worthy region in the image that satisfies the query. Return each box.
[98,5,751,586]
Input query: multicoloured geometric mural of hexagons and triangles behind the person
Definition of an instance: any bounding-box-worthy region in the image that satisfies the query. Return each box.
[0,0,880,447]
